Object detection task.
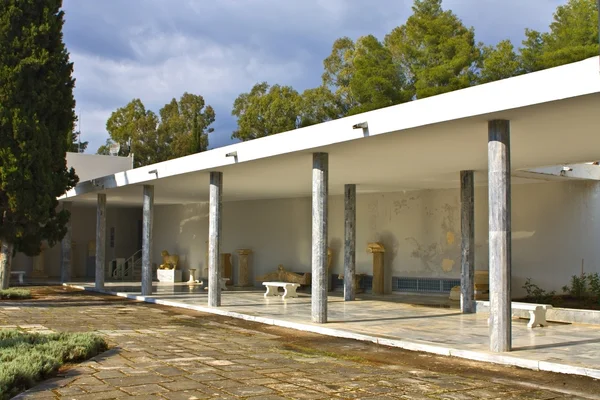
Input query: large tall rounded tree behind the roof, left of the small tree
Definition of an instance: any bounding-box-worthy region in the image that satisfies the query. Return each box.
[385,0,480,99]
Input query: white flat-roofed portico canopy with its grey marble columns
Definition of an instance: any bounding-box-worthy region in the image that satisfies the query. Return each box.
[62,57,600,352]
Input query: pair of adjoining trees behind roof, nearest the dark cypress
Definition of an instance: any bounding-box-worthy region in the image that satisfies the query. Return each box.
[98,92,215,167]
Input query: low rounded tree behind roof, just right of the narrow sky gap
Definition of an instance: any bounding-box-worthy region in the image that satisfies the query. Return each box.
[231,82,301,141]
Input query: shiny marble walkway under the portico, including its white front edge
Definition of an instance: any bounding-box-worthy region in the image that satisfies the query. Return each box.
[71,284,600,378]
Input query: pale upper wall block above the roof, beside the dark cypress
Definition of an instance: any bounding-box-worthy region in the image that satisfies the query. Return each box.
[67,153,133,182]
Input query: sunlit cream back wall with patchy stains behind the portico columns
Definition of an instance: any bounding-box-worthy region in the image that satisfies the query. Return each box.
[154,182,600,295]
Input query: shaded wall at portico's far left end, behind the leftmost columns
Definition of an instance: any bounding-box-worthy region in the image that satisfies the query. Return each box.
[12,204,142,278]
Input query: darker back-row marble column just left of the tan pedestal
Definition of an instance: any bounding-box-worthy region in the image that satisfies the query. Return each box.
[344,185,356,301]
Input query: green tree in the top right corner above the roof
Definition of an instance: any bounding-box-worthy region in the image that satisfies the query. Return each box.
[521,0,599,72]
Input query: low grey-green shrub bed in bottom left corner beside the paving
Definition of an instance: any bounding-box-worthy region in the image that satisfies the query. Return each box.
[0,330,108,400]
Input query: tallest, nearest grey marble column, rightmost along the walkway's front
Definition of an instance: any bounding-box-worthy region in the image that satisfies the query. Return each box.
[488,120,512,352]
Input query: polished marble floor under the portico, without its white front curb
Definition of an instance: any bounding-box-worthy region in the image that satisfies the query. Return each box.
[69,283,600,375]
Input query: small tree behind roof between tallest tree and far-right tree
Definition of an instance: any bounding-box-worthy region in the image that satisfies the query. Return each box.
[478,40,521,83]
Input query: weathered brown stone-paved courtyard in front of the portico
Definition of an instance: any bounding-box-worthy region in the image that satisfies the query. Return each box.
[0,288,598,400]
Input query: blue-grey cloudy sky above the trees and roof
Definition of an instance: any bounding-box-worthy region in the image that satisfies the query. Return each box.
[63,0,566,153]
